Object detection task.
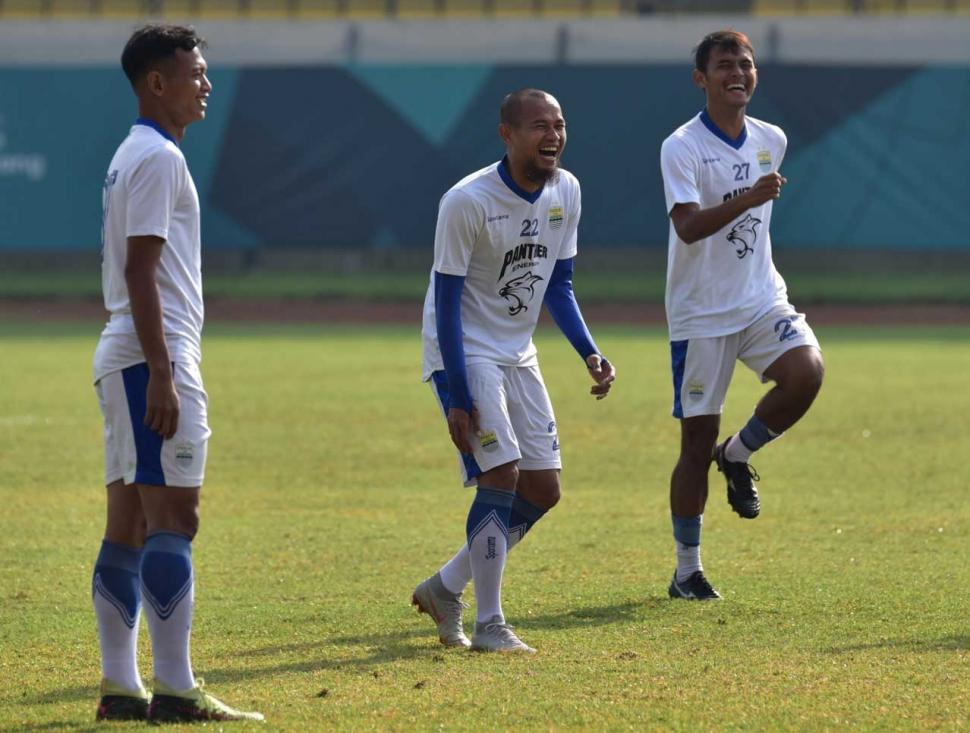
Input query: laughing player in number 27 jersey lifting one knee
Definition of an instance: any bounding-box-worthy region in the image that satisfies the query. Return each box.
[660,30,824,600]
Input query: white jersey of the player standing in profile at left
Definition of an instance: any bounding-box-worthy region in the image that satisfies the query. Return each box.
[94,120,203,381]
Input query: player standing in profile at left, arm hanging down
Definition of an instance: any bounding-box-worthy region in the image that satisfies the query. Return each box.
[92,25,263,722]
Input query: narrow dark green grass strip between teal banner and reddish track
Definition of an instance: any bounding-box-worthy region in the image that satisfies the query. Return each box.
[0,264,970,304]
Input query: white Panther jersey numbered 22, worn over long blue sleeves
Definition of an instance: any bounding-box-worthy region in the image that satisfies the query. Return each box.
[422,160,581,380]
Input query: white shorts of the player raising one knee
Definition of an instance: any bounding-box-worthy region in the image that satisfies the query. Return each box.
[670,303,819,418]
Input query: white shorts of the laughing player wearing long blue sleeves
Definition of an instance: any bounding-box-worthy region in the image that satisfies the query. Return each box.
[431,364,562,486]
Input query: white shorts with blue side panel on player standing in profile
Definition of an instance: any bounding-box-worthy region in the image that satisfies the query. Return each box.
[95,362,211,488]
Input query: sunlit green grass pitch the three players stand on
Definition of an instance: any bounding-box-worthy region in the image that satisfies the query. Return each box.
[0,324,970,731]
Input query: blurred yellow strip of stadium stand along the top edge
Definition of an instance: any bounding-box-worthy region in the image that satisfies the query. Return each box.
[0,0,970,20]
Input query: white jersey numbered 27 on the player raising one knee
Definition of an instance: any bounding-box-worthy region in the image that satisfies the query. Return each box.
[660,110,788,341]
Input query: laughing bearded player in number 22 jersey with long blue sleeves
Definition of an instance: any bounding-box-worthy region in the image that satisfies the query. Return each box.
[411,89,615,652]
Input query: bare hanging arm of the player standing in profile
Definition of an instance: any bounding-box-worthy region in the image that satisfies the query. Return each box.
[125,236,179,439]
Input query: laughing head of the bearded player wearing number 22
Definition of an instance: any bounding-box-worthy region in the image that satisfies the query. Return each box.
[499,93,566,185]
